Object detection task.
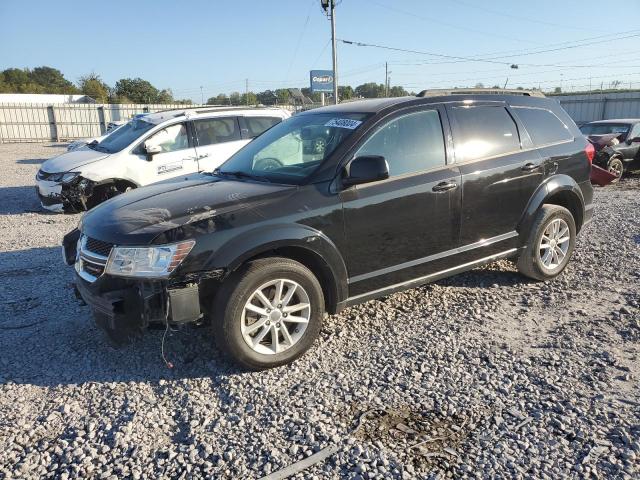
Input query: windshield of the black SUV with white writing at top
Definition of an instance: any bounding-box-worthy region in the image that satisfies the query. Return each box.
[214,113,367,185]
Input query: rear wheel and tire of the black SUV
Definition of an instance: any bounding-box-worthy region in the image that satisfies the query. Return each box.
[517,205,576,281]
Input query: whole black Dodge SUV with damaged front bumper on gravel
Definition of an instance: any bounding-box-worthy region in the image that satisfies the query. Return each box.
[63,92,593,369]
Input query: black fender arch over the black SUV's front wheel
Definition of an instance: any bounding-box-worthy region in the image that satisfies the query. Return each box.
[206,224,348,307]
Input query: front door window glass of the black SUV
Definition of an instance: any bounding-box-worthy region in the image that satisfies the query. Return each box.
[356,110,446,177]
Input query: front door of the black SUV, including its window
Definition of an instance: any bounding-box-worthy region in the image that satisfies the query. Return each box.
[340,107,461,296]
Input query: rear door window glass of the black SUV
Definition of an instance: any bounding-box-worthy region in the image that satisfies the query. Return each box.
[452,106,520,162]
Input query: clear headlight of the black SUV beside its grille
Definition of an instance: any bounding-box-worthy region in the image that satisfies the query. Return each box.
[105,240,196,278]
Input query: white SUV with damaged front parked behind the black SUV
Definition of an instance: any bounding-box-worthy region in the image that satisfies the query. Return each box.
[36,107,290,212]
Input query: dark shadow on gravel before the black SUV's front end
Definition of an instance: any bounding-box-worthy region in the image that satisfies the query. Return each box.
[0,247,244,387]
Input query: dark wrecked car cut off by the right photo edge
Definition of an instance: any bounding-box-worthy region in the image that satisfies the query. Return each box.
[580,118,640,181]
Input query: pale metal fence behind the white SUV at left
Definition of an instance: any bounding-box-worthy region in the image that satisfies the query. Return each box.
[0,103,206,143]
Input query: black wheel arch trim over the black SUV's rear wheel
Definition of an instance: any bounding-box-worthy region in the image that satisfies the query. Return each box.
[516,174,585,239]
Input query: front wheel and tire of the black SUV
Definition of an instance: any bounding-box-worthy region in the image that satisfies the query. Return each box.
[212,257,324,370]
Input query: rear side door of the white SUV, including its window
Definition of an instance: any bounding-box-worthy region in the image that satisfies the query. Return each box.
[193,116,248,172]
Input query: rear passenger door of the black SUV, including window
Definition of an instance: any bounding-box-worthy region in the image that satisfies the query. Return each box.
[447,102,543,253]
